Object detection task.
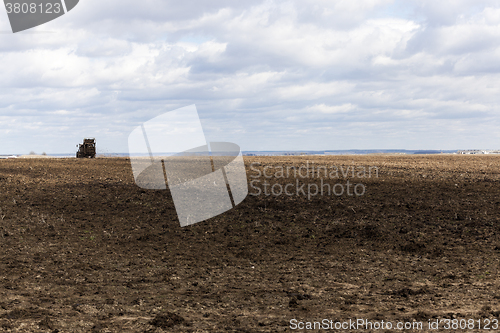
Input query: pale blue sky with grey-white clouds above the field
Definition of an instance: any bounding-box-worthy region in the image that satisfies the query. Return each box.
[0,0,500,154]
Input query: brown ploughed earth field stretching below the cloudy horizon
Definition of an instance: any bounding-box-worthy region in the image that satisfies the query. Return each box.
[0,155,500,332]
